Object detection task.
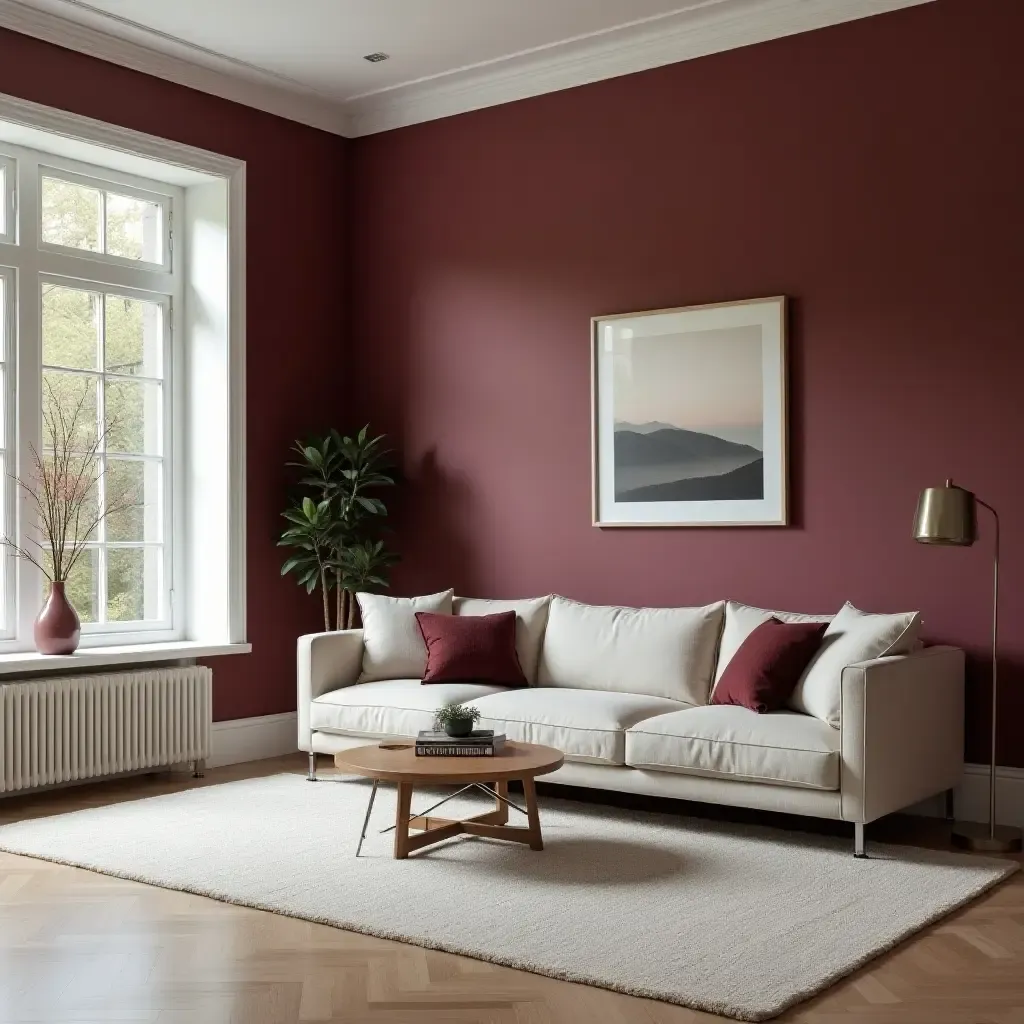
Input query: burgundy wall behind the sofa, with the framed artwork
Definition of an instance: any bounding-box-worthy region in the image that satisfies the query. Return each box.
[350,0,1024,765]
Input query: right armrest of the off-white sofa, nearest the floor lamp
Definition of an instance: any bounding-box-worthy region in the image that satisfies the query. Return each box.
[841,647,964,822]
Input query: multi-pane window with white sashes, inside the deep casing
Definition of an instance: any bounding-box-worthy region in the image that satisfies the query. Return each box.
[0,142,182,647]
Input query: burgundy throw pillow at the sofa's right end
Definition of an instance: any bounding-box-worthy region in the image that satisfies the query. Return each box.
[711,618,828,715]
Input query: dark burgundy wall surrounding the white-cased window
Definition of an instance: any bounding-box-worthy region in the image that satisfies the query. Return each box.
[0,30,347,720]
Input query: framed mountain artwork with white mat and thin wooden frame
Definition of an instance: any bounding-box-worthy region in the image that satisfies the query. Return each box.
[591,298,787,526]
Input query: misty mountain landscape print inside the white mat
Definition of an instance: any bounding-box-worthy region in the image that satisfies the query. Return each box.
[614,327,765,502]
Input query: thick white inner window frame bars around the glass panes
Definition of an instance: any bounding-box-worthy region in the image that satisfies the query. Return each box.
[0,142,184,656]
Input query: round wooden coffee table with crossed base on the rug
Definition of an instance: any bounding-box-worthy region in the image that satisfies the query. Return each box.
[334,740,563,859]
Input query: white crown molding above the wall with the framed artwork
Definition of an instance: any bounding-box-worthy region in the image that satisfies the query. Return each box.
[347,0,933,137]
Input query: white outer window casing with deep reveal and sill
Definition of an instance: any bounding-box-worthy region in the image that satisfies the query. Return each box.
[0,93,252,676]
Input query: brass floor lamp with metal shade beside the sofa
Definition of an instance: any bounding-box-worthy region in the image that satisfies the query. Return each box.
[913,480,1021,853]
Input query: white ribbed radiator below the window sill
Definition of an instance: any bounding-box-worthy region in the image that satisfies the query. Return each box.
[0,666,213,793]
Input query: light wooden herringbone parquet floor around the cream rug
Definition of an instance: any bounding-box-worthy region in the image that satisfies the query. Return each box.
[0,758,1024,1024]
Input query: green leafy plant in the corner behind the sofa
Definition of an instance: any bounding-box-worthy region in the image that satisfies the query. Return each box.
[278,426,397,630]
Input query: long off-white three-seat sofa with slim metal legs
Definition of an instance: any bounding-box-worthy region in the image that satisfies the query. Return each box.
[298,598,964,856]
